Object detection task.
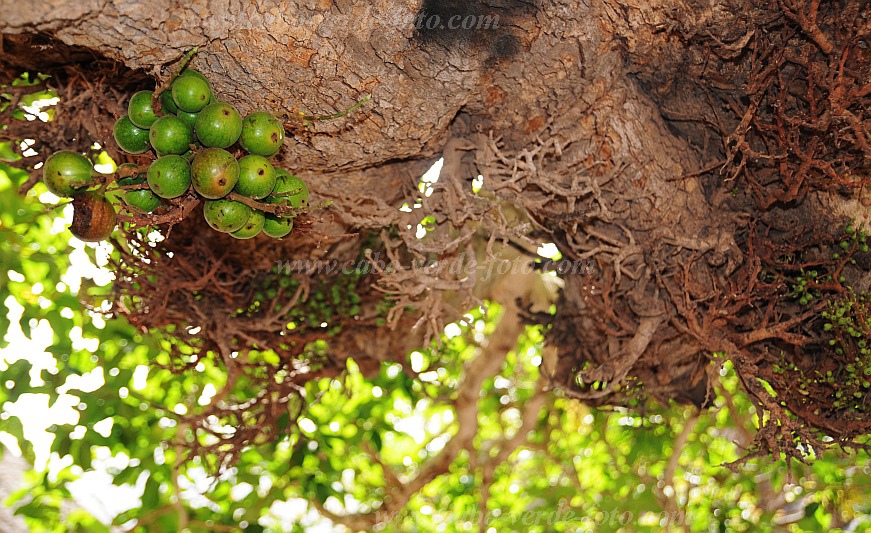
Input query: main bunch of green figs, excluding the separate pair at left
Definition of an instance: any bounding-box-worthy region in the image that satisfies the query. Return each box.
[113,69,309,239]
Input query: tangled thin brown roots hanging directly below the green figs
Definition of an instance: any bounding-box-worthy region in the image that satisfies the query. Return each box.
[112,208,416,461]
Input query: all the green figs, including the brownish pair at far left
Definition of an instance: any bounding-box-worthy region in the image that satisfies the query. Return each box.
[43,69,309,241]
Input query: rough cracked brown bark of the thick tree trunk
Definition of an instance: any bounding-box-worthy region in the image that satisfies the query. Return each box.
[0,0,871,482]
